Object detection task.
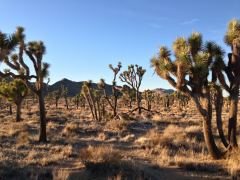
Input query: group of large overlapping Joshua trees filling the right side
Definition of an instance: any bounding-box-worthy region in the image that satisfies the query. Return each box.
[151,19,240,159]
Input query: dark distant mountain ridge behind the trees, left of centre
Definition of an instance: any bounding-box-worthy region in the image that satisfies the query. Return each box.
[48,78,112,97]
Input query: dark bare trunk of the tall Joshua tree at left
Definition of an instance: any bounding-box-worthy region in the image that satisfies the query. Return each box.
[37,89,47,142]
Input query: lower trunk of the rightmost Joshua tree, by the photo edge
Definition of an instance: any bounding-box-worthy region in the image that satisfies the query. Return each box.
[228,91,238,147]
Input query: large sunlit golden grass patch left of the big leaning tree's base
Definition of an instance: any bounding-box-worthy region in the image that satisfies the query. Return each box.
[135,125,207,166]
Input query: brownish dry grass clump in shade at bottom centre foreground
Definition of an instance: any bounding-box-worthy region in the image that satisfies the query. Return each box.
[80,145,149,180]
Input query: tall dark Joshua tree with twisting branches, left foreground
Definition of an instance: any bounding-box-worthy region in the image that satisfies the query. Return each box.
[0,27,49,142]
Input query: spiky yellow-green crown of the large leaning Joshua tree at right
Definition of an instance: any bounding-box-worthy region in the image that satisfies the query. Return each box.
[151,32,225,94]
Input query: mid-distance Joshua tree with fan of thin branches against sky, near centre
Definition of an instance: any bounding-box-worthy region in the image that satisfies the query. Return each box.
[119,65,146,114]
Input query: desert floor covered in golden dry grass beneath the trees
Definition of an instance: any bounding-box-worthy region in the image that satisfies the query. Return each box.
[0,102,240,180]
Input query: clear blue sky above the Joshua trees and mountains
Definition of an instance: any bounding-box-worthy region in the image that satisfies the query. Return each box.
[0,0,240,89]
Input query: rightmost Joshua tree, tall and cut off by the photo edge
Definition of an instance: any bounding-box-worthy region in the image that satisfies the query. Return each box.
[221,19,240,147]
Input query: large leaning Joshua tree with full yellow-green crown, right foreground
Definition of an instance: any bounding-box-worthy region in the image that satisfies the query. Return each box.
[151,33,224,159]
